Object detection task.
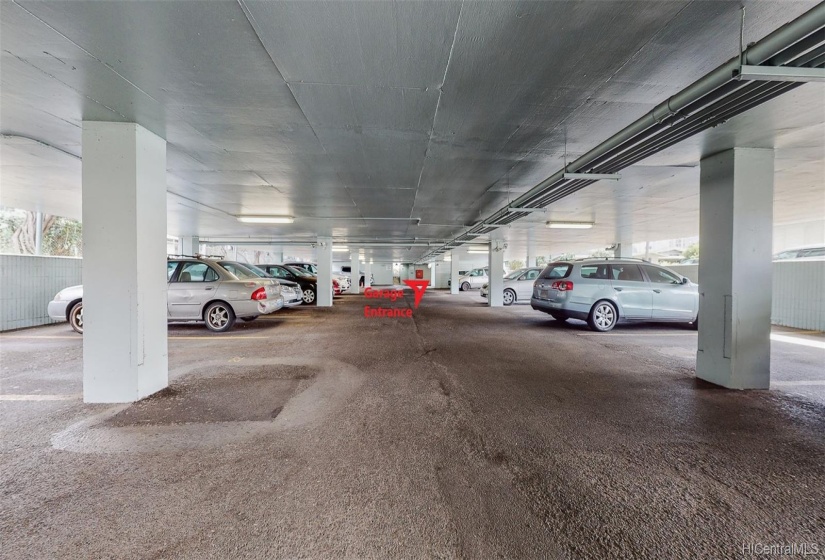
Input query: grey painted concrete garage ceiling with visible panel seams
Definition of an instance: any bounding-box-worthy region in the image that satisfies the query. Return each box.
[0,0,825,260]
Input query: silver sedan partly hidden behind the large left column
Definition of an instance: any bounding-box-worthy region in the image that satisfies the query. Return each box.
[48,257,284,334]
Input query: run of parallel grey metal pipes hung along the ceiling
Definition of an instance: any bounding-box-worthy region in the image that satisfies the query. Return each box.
[419,3,825,262]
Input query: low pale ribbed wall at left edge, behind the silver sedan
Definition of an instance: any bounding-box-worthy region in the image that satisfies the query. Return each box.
[0,255,83,331]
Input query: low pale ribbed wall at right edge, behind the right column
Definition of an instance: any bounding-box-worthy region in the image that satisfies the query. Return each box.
[668,260,825,331]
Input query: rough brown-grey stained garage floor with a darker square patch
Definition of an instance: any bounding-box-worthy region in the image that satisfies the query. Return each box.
[0,290,825,559]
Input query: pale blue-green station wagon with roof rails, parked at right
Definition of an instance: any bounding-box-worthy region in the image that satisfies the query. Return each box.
[530,258,699,332]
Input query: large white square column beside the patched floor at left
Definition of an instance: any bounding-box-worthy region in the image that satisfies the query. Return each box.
[82,121,169,403]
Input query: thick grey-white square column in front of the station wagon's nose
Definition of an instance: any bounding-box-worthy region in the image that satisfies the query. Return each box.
[696,148,774,389]
